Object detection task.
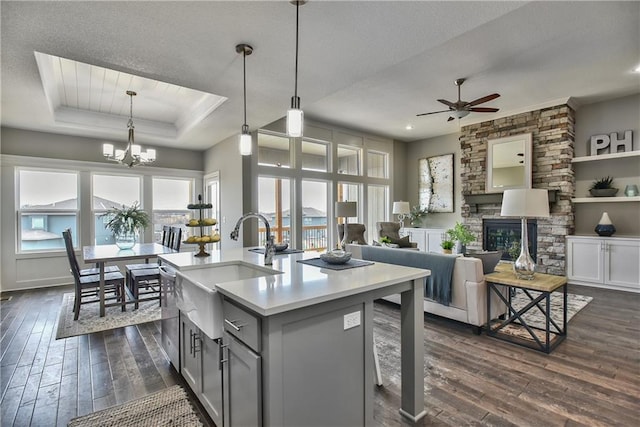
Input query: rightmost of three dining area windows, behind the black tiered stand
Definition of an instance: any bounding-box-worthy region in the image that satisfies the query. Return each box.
[152,178,193,243]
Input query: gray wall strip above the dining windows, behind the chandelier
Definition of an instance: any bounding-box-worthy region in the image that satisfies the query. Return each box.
[0,127,204,171]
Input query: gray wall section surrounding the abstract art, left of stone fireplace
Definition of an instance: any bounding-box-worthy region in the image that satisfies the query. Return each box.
[405,133,462,228]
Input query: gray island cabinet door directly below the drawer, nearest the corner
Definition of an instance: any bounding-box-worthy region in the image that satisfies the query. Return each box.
[223,331,262,427]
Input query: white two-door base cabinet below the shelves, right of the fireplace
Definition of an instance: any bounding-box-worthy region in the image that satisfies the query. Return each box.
[567,236,640,292]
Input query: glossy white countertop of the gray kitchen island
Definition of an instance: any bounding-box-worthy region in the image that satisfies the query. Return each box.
[159,248,431,316]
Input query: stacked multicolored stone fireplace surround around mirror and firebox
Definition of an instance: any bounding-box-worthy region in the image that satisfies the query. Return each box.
[460,104,575,275]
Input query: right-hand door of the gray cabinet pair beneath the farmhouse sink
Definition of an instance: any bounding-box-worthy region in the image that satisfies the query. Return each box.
[204,334,222,427]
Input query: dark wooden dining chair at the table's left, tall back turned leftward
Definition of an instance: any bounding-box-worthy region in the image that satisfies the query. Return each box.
[62,229,126,320]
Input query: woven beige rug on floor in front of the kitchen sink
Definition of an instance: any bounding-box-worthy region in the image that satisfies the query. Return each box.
[67,385,202,427]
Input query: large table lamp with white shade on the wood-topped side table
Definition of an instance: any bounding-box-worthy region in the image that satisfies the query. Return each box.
[500,188,549,280]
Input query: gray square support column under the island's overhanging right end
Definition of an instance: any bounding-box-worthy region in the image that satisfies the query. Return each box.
[400,278,427,422]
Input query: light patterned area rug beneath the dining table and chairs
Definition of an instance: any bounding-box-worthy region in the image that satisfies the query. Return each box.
[56,292,160,340]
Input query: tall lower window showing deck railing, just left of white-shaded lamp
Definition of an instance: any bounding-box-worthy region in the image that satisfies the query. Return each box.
[301,180,328,251]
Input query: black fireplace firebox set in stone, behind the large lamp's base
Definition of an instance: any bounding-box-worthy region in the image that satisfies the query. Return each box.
[482,219,538,262]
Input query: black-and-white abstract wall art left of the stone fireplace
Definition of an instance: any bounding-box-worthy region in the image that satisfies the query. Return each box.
[418,154,453,212]
